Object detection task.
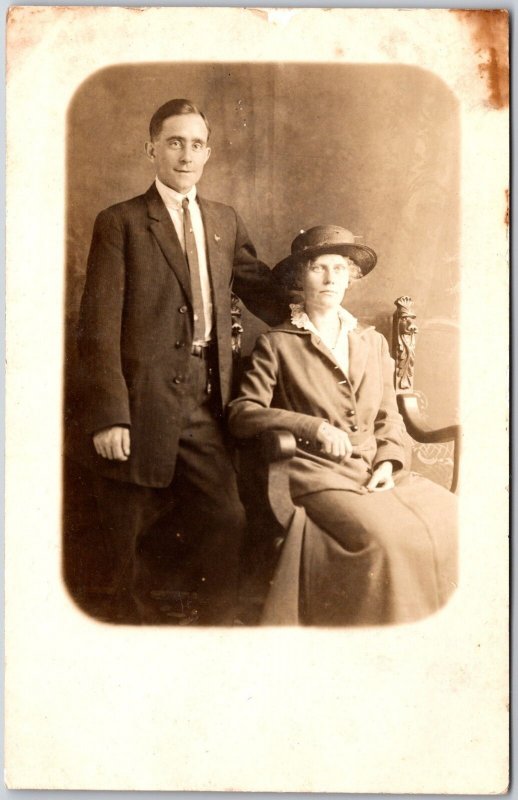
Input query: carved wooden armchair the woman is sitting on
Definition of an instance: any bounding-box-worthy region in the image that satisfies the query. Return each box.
[236,296,461,624]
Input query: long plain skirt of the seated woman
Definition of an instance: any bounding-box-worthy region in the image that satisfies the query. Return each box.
[263,473,457,625]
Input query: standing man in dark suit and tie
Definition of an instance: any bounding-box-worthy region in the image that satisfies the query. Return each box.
[79,99,286,624]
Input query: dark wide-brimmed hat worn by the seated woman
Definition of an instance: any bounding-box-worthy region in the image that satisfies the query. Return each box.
[273,225,378,286]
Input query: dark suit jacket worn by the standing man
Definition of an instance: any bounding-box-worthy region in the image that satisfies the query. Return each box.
[78,184,286,487]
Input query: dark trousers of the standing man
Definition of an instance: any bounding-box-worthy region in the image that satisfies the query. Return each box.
[95,356,245,624]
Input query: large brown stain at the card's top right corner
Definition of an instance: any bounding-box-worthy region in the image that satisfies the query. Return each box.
[450,8,509,109]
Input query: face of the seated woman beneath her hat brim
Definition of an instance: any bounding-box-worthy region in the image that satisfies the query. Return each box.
[302,253,349,311]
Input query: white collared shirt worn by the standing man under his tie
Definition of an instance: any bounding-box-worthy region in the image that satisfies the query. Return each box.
[155,178,212,344]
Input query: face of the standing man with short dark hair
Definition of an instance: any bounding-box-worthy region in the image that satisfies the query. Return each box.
[146,114,210,194]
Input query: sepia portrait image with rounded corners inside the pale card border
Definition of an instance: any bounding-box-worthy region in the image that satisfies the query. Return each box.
[63,63,460,625]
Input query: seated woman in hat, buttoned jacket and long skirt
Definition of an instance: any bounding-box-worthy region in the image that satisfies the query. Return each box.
[229,226,457,625]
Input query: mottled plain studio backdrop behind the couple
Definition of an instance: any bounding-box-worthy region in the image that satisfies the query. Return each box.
[66,64,459,432]
